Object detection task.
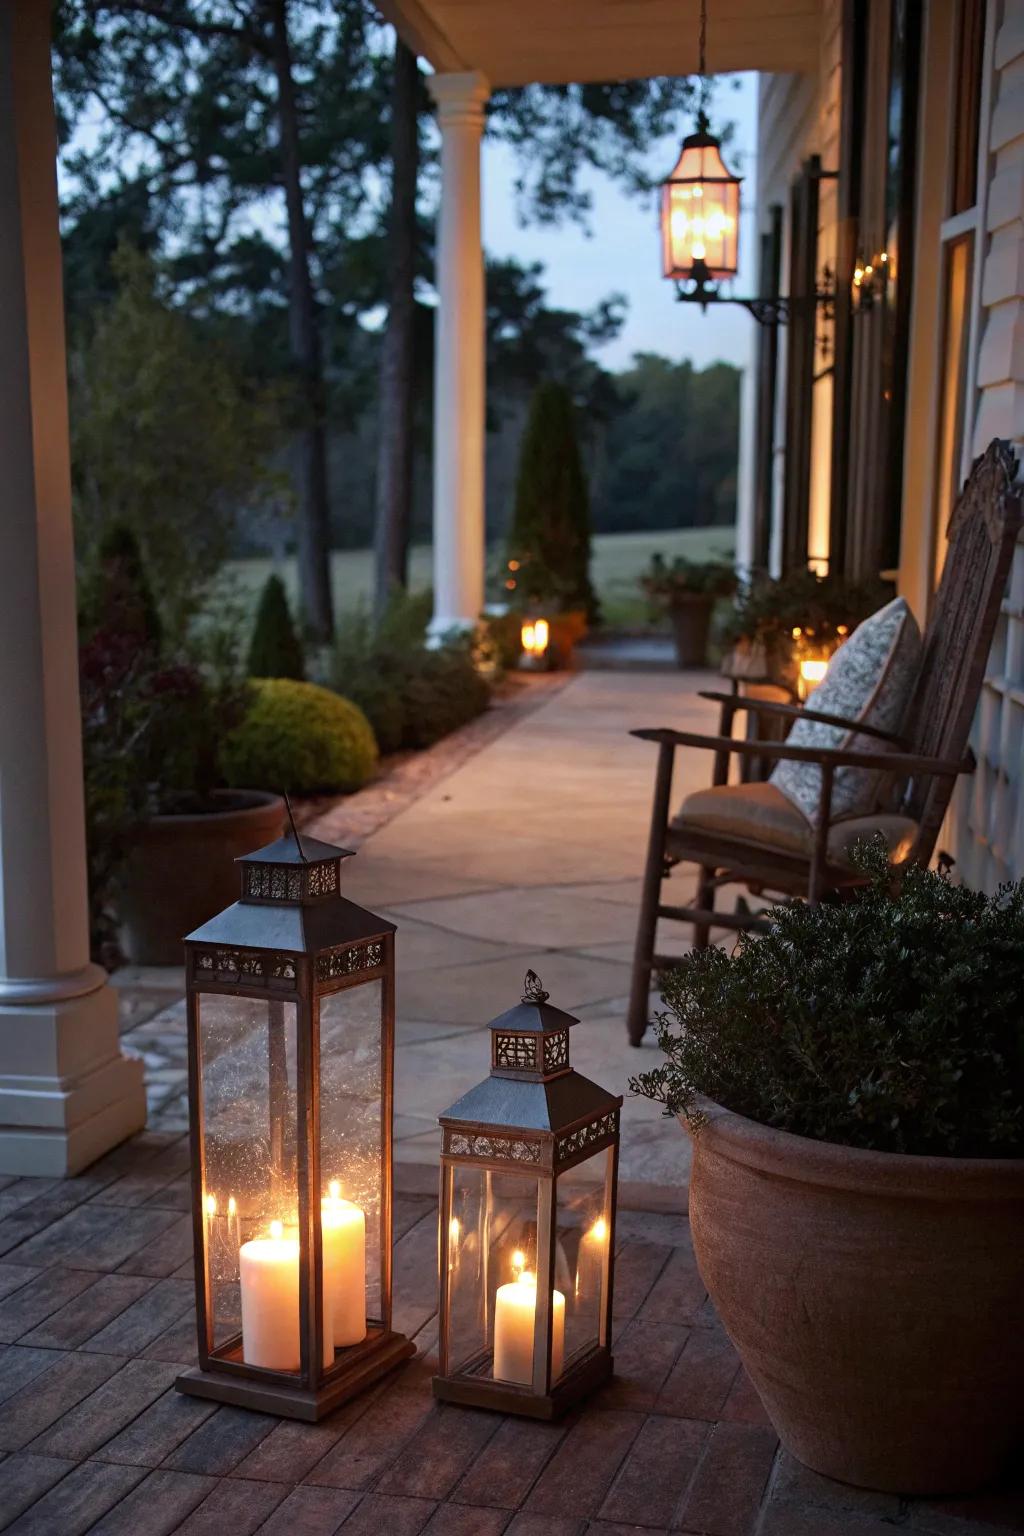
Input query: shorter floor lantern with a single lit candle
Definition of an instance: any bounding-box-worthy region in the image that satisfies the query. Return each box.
[434,971,622,1419]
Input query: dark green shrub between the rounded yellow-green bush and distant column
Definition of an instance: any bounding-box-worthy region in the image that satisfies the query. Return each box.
[332,593,490,753]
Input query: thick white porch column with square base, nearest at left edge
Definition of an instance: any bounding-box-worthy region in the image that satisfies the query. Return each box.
[0,0,146,1175]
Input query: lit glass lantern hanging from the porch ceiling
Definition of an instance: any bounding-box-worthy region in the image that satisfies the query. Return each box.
[662,112,740,290]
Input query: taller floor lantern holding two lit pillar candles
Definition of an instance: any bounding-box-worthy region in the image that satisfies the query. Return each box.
[177,831,415,1421]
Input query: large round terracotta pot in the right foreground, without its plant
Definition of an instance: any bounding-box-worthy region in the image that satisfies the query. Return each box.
[689,1104,1024,1495]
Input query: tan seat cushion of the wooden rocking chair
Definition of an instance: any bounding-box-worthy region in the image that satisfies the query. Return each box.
[671,782,917,868]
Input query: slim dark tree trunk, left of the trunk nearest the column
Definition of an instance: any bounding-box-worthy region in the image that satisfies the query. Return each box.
[266,0,335,644]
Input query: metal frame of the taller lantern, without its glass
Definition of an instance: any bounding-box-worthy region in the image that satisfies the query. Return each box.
[175,829,416,1422]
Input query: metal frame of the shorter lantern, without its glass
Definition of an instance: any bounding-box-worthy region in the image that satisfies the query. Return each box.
[433,971,622,1419]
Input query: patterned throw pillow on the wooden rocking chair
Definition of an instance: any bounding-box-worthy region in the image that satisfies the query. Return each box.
[771,598,921,823]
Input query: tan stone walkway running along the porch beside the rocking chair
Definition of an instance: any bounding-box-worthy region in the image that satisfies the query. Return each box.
[320,673,715,1198]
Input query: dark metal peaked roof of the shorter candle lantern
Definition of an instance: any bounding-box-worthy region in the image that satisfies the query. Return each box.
[439,971,622,1169]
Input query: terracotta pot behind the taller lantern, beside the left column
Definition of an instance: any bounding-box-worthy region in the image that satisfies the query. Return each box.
[120,790,284,965]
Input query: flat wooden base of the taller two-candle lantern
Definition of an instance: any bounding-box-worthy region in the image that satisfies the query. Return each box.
[175,1332,416,1424]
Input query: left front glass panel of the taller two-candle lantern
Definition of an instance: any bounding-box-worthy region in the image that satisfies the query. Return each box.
[197,994,299,1372]
